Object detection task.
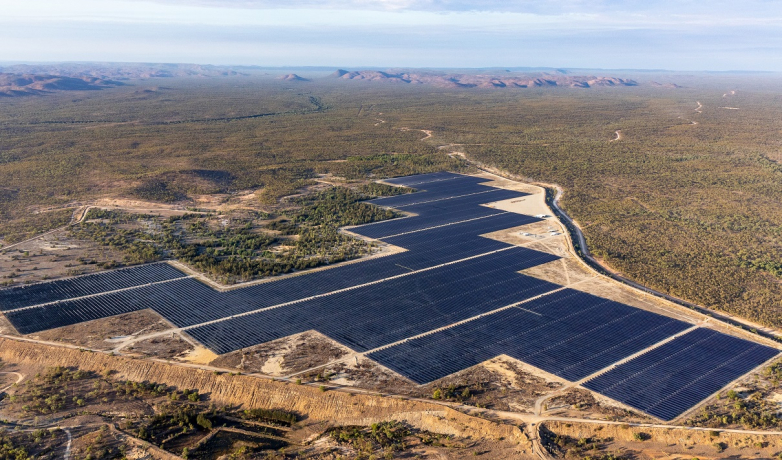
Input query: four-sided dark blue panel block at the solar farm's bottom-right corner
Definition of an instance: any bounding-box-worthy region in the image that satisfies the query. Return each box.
[584,328,779,420]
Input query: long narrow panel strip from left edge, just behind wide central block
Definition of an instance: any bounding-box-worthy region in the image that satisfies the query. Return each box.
[3,214,557,333]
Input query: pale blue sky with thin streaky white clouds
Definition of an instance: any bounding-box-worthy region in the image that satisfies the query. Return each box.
[0,0,782,71]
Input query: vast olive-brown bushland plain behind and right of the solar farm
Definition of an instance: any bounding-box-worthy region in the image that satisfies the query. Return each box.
[0,77,782,326]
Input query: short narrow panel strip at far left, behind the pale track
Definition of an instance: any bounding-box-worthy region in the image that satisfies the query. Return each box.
[0,264,186,311]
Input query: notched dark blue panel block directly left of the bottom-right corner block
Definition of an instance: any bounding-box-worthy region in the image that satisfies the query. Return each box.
[369,289,689,383]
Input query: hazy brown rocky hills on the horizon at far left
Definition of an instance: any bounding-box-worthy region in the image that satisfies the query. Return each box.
[0,73,121,97]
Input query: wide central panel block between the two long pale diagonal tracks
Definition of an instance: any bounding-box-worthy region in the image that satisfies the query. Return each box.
[188,248,559,353]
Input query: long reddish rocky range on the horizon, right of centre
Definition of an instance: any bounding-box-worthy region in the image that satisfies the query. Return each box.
[331,70,638,88]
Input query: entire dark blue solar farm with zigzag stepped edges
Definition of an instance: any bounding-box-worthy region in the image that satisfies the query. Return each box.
[0,172,778,420]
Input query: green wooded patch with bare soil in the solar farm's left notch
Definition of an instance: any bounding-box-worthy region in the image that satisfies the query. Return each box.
[70,184,405,284]
